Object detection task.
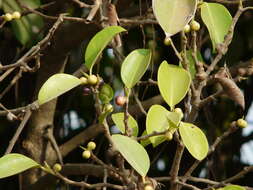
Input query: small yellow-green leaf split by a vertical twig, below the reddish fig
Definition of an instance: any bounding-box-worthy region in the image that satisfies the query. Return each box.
[112,112,139,137]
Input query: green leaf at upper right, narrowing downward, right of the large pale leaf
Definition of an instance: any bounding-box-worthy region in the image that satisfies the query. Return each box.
[200,3,232,50]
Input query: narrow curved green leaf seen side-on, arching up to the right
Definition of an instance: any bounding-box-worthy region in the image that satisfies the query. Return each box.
[85,26,126,71]
